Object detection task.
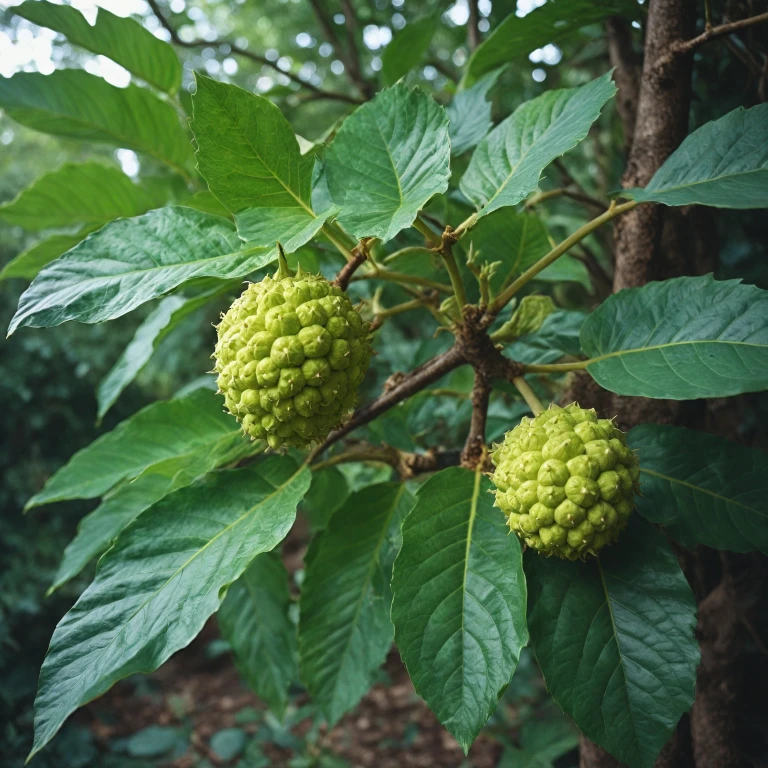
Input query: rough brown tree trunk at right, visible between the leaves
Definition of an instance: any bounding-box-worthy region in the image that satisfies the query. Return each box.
[580,0,759,768]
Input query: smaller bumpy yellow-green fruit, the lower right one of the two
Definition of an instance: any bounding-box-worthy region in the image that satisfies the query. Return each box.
[491,403,639,560]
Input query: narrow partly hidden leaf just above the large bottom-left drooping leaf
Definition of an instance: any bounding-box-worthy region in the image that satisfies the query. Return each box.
[49,432,264,592]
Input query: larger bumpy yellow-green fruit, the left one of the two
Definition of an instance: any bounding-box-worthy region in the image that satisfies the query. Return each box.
[213,271,372,449]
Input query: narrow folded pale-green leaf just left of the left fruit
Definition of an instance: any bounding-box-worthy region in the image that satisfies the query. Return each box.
[96,282,231,421]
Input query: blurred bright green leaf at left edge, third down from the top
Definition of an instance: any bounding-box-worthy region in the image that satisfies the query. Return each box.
[0,161,153,232]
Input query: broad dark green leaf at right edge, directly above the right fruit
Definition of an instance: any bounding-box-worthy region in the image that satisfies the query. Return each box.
[581,275,768,400]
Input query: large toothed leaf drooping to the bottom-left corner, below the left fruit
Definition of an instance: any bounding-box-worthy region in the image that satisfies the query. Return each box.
[30,456,309,757]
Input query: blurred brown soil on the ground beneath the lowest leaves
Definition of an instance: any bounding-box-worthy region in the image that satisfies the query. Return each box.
[78,622,501,768]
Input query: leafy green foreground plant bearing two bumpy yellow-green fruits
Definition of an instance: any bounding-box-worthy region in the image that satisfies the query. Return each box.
[0,0,768,768]
